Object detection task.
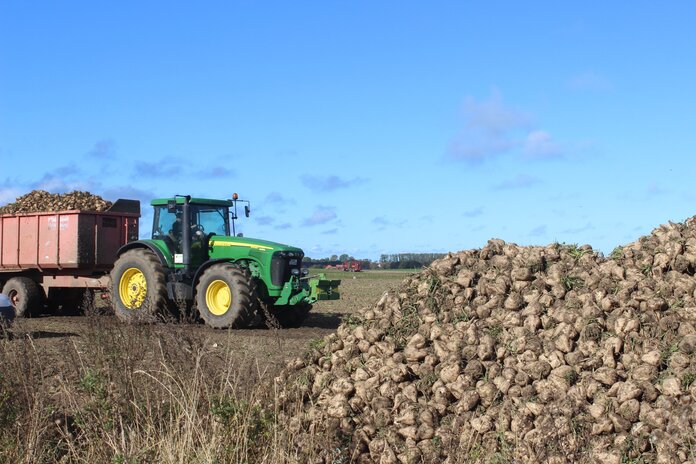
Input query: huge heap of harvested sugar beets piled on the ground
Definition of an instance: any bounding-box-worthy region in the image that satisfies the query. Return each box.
[276,216,696,464]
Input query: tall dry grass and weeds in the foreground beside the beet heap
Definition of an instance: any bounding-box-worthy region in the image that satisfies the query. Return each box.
[0,318,308,463]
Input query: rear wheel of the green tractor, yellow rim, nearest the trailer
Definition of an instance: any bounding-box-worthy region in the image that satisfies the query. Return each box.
[111,248,167,323]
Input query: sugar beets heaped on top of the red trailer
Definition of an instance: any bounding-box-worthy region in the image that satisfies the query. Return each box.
[0,190,112,214]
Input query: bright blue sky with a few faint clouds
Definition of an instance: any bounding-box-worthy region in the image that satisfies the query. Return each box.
[0,0,696,258]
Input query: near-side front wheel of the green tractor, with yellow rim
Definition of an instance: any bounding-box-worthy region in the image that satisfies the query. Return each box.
[196,264,258,329]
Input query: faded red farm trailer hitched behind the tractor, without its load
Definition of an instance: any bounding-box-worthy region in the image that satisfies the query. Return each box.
[0,199,140,316]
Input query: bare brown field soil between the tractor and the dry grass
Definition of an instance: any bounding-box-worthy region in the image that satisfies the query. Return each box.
[5,271,408,383]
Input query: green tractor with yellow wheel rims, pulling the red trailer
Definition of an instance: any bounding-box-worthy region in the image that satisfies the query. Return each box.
[111,193,340,328]
